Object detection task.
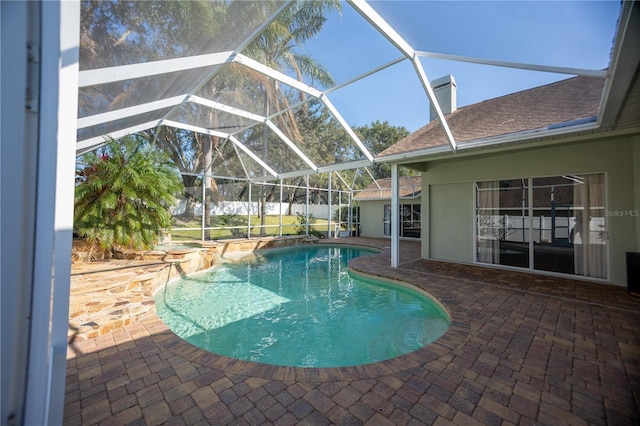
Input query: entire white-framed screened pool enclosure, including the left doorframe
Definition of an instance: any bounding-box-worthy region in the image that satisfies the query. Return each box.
[1,0,624,425]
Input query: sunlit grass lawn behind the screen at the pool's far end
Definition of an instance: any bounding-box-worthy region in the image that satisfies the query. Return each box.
[170,215,336,241]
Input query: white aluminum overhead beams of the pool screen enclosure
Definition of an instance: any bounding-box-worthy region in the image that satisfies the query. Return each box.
[71,0,608,178]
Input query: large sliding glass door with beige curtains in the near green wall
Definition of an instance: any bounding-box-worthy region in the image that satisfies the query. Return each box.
[476,174,608,278]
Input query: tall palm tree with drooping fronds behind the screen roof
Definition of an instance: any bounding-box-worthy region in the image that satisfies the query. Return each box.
[244,0,341,235]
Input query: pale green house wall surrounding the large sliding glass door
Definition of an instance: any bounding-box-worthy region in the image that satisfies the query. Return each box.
[422,135,640,286]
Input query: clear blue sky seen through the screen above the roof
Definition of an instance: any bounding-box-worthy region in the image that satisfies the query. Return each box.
[304,1,620,131]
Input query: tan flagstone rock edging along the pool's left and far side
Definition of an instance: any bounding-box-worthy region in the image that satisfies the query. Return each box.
[68,236,317,341]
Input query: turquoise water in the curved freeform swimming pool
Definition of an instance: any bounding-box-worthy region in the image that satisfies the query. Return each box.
[156,245,449,367]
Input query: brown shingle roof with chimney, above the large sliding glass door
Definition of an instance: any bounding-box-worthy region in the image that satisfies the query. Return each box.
[378,77,604,157]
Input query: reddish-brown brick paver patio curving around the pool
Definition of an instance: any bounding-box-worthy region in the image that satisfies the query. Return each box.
[64,238,640,426]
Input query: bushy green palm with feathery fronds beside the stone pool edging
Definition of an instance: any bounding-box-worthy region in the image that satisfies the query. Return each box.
[74,136,183,251]
